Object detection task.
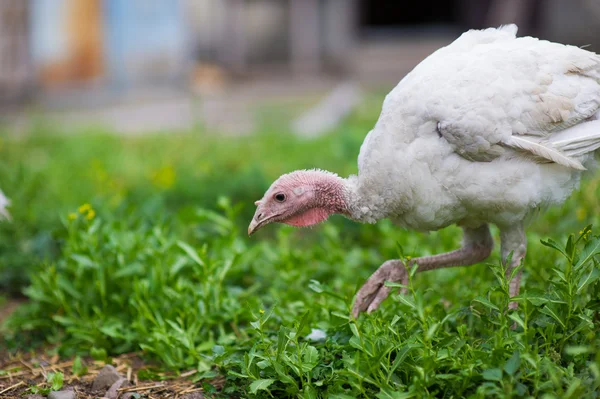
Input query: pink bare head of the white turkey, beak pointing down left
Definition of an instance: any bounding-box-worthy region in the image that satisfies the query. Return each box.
[248,170,347,235]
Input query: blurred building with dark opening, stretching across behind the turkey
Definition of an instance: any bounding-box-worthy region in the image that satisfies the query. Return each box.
[0,0,600,108]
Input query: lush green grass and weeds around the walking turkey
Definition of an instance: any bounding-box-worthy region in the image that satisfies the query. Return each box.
[0,99,600,398]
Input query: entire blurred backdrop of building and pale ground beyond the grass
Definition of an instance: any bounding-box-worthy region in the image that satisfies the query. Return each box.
[0,0,600,134]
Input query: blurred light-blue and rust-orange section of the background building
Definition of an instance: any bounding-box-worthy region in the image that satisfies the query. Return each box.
[29,0,187,88]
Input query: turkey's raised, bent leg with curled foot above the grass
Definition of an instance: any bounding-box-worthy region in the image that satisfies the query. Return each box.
[352,224,492,318]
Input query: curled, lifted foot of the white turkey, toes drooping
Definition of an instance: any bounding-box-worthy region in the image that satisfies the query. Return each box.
[352,259,408,318]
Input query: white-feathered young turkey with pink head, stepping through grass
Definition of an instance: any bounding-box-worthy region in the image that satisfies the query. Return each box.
[248,25,600,317]
